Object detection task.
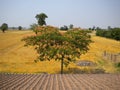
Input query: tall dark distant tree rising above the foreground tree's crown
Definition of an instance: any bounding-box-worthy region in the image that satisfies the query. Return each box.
[35,13,48,26]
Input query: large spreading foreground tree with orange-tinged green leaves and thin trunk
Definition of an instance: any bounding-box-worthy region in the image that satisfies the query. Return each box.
[23,26,91,74]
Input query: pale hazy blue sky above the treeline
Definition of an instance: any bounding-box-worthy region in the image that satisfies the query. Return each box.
[0,0,120,28]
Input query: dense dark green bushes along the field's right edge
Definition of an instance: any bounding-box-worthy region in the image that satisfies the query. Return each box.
[96,28,120,40]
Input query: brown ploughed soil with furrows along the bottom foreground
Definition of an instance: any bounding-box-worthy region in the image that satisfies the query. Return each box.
[0,74,120,90]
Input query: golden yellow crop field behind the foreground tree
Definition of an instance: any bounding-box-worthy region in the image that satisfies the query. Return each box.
[0,31,120,73]
